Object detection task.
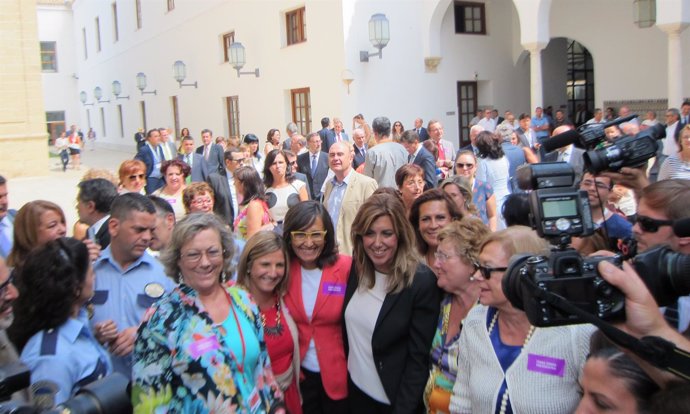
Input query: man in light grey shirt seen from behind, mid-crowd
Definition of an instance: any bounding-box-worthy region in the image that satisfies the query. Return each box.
[364,116,409,188]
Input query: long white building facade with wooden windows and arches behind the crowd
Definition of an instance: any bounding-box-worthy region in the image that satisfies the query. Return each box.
[39,0,690,149]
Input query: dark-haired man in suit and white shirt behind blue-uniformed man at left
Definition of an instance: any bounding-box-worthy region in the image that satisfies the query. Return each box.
[77,178,117,250]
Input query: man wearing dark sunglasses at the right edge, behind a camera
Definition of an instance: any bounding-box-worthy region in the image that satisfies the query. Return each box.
[633,179,690,332]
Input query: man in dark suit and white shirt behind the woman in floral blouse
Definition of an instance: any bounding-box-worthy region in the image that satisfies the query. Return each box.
[206,148,247,228]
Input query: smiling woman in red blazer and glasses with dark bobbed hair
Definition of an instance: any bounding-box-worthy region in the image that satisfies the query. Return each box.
[283,201,352,414]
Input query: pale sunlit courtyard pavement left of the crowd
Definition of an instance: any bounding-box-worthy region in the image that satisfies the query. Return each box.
[7,144,134,235]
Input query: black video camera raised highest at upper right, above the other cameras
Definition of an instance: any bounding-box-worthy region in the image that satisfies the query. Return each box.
[582,124,666,174]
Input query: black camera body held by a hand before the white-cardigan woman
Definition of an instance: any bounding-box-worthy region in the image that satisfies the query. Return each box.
[502,249,625,327]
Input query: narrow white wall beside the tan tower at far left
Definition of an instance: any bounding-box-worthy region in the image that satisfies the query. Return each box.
[36,5,79,135]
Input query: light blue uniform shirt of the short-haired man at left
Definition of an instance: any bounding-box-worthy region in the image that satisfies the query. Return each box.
[91,246,175,378]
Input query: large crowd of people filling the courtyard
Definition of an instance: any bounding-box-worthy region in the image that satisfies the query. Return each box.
[0,102,690,414]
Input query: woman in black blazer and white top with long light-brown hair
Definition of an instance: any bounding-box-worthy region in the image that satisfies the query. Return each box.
[343,194,441,413]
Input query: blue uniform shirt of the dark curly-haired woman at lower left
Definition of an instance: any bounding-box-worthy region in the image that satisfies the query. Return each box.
[20,309,113,404]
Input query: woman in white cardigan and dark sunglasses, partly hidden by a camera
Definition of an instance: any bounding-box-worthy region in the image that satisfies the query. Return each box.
[450,226,594,413]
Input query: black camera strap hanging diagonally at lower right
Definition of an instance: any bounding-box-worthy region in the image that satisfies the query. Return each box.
[522,277,690,381]
